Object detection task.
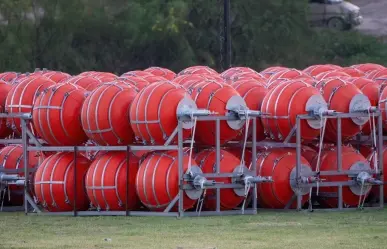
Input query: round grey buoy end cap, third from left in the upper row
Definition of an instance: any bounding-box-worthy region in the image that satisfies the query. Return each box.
[305,95,328,130]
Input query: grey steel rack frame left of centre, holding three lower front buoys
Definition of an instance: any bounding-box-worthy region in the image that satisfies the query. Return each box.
[9,114,264,217]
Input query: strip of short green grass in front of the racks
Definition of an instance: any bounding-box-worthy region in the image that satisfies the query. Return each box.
[0,210,387,249]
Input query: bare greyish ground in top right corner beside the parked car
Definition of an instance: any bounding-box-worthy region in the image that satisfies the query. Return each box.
[351,0,387,37]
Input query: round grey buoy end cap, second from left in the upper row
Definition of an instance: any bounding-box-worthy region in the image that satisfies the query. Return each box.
[226,95,249,130]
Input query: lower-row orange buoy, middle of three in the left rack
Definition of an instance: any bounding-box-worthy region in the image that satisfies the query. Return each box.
[85,152,139,211]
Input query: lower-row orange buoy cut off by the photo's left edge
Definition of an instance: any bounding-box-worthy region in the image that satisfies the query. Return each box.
[0,145,43,205]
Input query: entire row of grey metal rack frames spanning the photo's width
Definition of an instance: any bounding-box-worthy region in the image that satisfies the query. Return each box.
[0,111,384,217]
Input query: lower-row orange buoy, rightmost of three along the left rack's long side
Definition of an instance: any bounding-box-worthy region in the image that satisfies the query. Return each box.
[136,151,202,211]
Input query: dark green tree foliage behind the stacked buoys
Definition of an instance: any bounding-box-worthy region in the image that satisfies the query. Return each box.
[0,0,387,74]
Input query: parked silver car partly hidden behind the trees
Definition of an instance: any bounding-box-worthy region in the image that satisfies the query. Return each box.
[308,0,363,30]
